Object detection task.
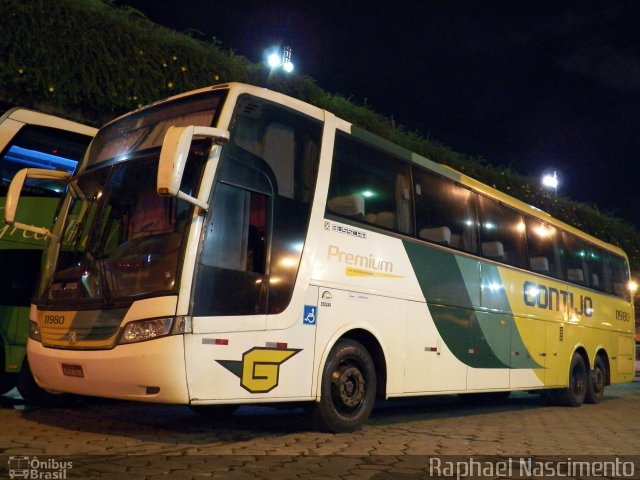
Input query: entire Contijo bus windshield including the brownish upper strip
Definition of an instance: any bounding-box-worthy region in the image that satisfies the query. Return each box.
[42,91,224,306]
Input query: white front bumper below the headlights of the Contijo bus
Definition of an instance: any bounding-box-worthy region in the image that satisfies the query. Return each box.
[27,335,189,404]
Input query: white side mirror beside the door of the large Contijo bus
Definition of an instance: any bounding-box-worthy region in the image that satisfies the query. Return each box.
[156,125,229,210]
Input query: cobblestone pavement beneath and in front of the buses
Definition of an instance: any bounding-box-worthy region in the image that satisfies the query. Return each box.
[0,382,640,480]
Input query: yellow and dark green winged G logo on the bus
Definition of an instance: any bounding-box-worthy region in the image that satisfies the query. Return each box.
[216,347,302,393]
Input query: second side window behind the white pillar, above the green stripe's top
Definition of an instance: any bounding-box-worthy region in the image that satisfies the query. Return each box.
[413,168,478,253]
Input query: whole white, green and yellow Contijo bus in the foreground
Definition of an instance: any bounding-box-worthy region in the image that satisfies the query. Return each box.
[6,83,634,432]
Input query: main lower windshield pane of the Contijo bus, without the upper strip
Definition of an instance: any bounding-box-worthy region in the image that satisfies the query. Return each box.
[45,142,208,303]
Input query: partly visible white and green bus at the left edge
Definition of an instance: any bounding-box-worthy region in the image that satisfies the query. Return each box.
[0,108,98,401]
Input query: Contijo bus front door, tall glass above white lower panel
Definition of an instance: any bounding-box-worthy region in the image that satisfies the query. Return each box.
[185,158,272,401]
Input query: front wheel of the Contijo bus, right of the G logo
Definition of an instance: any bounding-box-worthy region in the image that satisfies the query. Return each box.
[312,339,376,433]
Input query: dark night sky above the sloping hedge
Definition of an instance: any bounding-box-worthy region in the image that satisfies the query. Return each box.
[116,0,640,227]
